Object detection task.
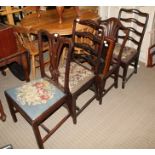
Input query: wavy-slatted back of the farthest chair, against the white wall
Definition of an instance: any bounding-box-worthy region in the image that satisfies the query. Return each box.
[118,8,149,54]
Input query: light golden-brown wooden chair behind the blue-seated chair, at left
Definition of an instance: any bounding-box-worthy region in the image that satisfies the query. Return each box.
[14,26,49,79]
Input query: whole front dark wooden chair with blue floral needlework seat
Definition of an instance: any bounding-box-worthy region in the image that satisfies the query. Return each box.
[5,30,75,148]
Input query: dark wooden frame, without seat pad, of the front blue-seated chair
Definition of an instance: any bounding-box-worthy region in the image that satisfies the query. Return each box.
[5,30,74,148]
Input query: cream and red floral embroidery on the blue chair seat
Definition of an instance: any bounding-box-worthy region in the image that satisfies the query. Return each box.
[16,79,54,105]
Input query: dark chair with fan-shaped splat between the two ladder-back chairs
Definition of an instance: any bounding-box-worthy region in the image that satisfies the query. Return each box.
[98,17,129,104]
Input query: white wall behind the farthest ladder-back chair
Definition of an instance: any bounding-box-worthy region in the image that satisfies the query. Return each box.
[99,6,155,64]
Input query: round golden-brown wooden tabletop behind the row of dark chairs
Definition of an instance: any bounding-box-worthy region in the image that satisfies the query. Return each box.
[21,8,100,35]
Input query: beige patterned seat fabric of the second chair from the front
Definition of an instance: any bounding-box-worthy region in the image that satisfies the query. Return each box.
[46,62,95,93]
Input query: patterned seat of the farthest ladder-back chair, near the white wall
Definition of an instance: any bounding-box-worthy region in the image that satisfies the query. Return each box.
[114,43,137,63]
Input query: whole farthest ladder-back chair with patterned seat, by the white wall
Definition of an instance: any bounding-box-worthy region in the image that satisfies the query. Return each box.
[115,8,149,88]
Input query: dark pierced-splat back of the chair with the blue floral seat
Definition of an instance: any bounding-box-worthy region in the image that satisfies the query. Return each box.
[38,30,72,93]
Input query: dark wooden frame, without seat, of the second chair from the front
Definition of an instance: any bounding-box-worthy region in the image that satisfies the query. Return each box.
[71,18,104,121]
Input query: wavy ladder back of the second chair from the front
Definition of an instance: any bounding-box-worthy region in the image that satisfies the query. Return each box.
[72,18,104,73]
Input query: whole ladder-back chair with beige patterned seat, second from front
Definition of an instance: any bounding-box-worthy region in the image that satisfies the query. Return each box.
[69,18,104,121]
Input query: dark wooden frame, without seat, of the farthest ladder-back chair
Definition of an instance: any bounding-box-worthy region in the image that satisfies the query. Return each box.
[118,8,149,88]
